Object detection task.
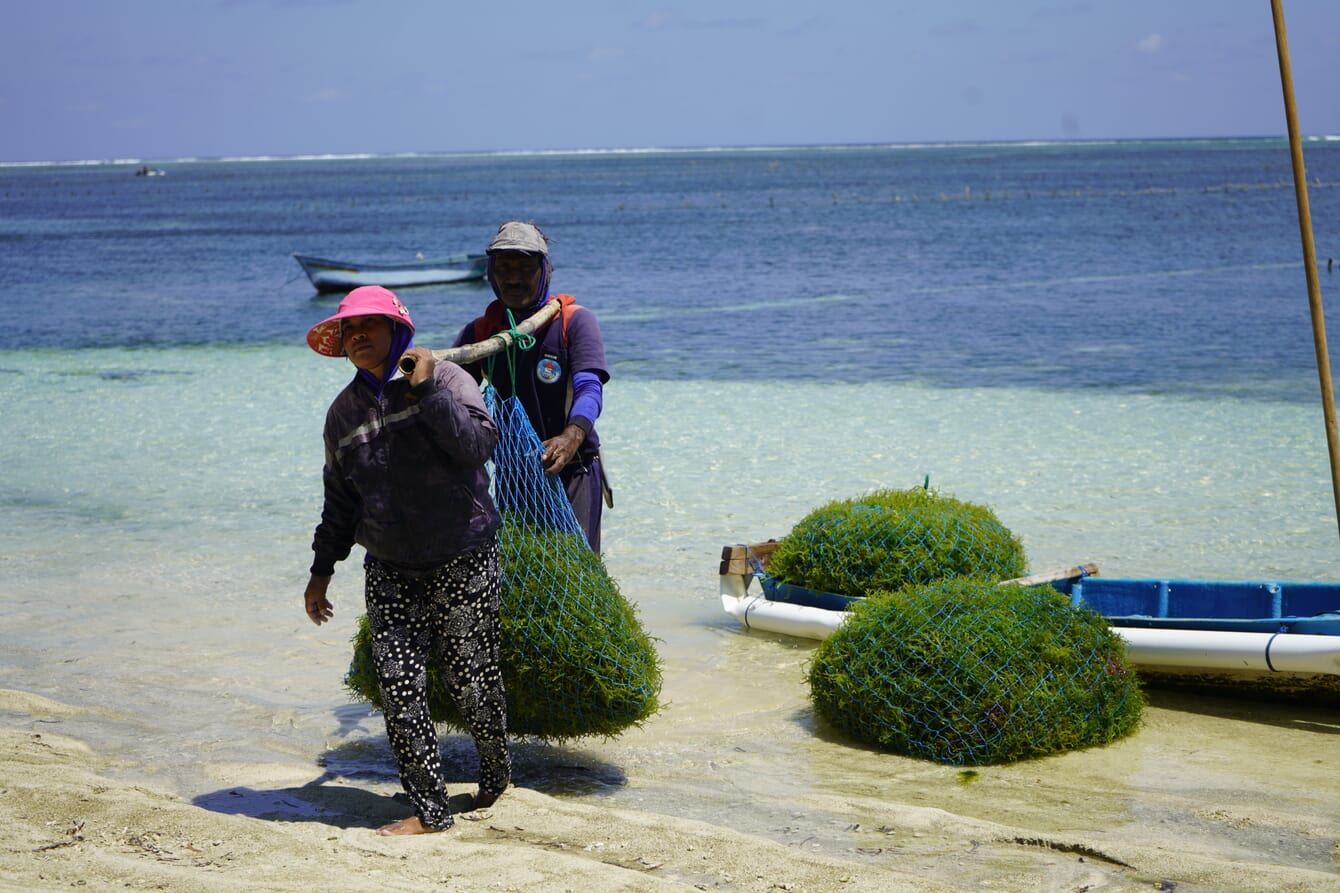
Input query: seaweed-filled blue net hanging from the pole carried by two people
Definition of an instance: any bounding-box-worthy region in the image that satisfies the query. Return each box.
[344,388,661,740]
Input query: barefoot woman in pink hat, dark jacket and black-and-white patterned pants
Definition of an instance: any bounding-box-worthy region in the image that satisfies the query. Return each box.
[303,286,512,835]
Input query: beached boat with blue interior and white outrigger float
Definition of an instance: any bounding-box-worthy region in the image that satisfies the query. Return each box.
[718,540,1340,704]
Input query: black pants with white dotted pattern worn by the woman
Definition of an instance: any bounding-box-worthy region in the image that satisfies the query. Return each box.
[364,542,512,829]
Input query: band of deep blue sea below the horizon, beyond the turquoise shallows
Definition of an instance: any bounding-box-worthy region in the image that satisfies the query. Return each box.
[0,139,1340,400]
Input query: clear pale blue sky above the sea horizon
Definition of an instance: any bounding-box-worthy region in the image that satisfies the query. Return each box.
[0,0,1340,161]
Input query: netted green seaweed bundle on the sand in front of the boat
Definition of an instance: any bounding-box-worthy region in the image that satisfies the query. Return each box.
[809,578,1144,766]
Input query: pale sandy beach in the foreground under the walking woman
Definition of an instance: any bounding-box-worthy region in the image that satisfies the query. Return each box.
[0,670,1340,893]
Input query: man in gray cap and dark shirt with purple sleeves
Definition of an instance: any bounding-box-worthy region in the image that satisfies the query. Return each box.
[456,220,614,552]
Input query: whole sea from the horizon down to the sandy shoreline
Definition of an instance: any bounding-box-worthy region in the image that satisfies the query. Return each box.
[0,139,1340,835]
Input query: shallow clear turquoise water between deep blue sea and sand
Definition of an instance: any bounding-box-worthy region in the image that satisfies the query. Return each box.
[0,347,1337,794]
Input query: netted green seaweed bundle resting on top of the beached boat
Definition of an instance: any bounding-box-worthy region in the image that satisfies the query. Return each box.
[768,487,1026,598]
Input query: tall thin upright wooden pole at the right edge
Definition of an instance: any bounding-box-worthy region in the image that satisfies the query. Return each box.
[1270,0,1340,536]
